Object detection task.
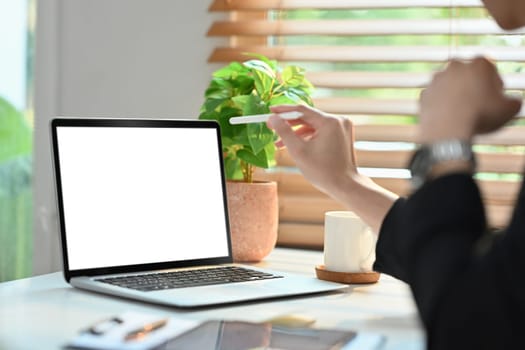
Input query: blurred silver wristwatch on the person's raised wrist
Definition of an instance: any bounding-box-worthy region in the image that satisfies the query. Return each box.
[409,139,476,190]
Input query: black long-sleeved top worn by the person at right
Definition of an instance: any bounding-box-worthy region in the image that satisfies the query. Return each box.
[374,174,525,349]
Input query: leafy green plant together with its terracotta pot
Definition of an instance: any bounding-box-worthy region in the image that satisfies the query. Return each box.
[199,55,313,261]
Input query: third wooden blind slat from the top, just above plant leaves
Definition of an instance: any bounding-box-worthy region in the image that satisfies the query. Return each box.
[208,45,525,63]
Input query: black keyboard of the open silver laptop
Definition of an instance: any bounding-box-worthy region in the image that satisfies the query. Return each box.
[96,266,282,292]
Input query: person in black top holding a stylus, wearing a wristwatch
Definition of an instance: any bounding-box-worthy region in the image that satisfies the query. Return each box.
[268,0,525,349]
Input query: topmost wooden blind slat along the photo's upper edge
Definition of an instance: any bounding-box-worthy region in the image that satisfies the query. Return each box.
[209,0,482,11]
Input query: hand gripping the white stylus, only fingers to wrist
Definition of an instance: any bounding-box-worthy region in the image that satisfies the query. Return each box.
[268,105,357,194]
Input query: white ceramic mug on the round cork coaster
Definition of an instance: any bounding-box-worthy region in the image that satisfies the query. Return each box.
[324,211,376,272]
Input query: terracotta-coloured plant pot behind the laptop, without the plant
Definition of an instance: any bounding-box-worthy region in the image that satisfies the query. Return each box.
[227,181,279,262]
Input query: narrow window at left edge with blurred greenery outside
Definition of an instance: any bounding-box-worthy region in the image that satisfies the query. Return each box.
[0,1,35,282]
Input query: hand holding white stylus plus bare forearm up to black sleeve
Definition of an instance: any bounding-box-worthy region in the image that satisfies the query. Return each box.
[268,106,397,233]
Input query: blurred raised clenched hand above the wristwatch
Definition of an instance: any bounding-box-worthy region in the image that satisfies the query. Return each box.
[419,57,521,143]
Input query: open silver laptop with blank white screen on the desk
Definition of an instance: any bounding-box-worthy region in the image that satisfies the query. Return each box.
[51,117,346,308]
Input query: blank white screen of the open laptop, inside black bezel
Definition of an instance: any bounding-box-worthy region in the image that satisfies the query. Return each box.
[57,126,228,270]
